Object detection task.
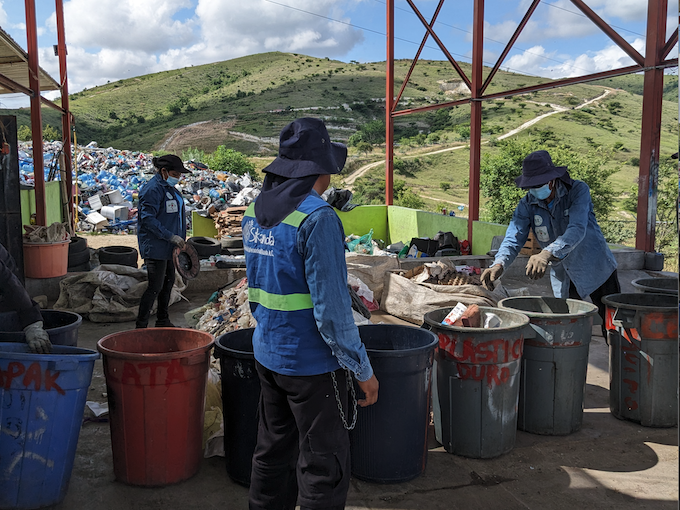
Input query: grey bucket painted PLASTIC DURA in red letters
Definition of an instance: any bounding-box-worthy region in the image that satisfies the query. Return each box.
[423,306,529,459]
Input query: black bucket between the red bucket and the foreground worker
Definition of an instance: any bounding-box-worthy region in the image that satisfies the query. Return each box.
[214,328,260,487]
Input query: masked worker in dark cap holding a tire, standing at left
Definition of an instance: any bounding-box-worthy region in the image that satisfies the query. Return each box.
[136,154,191,328]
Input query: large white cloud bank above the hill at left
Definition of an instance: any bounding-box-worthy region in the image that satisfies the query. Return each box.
[33,0,363,92]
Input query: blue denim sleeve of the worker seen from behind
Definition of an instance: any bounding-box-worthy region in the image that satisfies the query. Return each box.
[297,191,373,381]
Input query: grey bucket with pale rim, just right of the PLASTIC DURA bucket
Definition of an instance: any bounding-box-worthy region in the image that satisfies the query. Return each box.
[498,296,597,436]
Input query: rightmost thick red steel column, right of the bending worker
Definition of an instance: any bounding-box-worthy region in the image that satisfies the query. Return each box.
[635,0,668,251]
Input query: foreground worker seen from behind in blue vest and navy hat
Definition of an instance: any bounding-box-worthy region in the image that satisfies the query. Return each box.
[242,118,380,510]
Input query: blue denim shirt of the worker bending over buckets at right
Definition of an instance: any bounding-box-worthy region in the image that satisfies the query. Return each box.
[494,180,616,298]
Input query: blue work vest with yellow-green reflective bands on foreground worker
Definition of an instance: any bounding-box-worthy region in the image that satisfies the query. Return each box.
[241,196,340,376]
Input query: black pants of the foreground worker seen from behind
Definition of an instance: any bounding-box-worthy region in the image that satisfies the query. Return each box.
[249,363,353,510]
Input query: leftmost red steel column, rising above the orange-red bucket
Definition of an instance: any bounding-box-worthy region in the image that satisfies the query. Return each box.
[24,0,47,225]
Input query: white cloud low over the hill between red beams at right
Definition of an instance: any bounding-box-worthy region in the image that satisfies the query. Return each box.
[503,39,645,78]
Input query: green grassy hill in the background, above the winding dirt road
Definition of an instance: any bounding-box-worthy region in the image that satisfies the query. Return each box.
[5,52,677,156]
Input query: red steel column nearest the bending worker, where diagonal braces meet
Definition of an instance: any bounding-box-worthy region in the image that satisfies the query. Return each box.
[468,0,484,249]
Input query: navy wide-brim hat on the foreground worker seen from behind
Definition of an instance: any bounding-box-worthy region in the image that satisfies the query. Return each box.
[262,117,347,179]
